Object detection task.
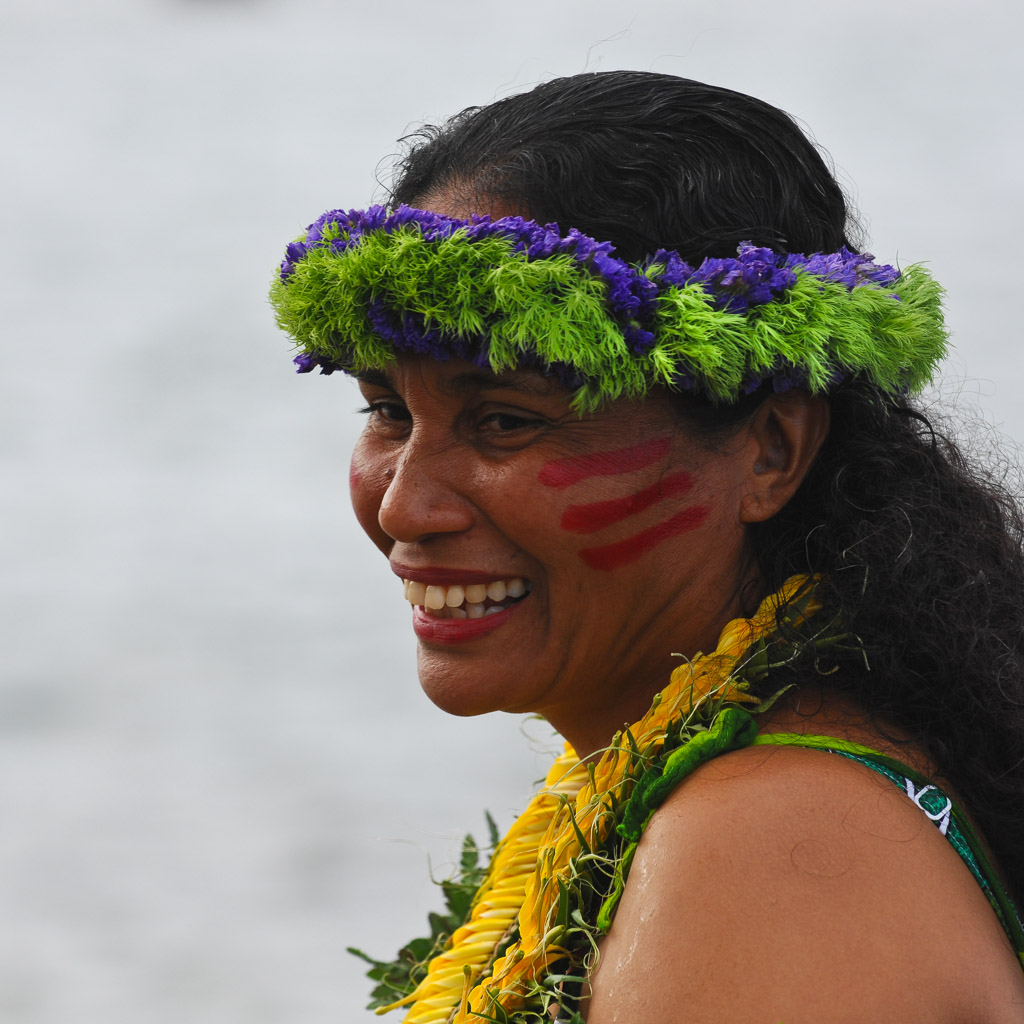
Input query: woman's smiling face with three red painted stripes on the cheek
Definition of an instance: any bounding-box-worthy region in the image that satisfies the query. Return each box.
[351,357,755,753]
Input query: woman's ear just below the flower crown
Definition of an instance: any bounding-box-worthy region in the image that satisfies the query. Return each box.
[739,390,829,522]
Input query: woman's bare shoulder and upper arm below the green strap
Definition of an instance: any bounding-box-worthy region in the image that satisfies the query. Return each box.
[588,746,1024,1024]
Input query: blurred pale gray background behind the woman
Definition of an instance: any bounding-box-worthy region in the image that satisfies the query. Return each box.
[0,0,1024,1024]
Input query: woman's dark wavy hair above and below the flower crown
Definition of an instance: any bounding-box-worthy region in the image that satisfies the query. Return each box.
[392,72,1024,894]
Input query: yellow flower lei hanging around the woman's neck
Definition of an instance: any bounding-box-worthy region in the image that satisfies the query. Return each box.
[377,575,818,1024]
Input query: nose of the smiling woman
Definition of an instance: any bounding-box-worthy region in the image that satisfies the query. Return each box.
[377,444,473,544]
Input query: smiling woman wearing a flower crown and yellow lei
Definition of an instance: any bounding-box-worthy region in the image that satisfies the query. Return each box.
[272,72,1024,1024]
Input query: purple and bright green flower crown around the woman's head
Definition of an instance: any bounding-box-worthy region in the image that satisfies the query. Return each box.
[270,206,946,410]
